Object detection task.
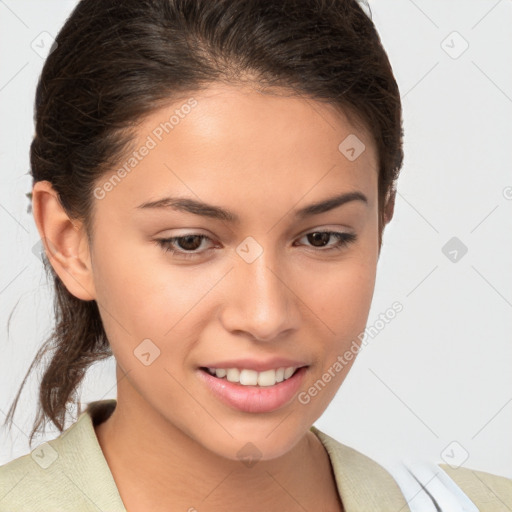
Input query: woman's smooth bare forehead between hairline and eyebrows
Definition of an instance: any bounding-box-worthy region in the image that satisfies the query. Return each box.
[95,84,378,218]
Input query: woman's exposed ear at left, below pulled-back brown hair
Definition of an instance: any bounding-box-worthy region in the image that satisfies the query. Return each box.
[32,181,96,301]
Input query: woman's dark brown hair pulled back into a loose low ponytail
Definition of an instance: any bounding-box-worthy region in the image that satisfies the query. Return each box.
[6,0,403,444]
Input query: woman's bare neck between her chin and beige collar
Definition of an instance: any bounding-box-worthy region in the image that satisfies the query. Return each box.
[95,389,340,512]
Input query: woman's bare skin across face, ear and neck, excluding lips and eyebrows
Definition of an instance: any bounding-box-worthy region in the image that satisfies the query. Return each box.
[33,84,393,511]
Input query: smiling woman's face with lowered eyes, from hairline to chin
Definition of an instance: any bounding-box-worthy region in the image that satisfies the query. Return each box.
[84,85,379,459]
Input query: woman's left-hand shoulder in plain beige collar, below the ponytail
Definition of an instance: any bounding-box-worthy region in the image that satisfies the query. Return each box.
[0,401,124,512]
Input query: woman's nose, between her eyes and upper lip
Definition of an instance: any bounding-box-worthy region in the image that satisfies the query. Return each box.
[220,251,300,341]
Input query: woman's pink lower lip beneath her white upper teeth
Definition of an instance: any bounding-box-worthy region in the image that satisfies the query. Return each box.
[197,366,307,412]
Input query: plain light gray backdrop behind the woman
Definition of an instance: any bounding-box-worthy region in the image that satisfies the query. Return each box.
[0,0,512,477]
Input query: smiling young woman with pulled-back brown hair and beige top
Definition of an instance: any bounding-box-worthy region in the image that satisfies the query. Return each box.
[0,0,511,512]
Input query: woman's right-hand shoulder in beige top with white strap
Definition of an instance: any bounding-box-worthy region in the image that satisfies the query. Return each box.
[311,427,512,512]
